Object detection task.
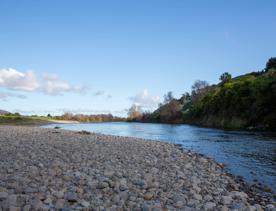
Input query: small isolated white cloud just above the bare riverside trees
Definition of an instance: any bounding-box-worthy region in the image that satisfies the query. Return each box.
[130,89,160,108]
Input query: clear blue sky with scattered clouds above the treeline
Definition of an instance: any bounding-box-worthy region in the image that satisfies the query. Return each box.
[0,0,276,116]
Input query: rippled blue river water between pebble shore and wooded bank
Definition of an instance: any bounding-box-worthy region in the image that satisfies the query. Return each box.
[43,122,276,191]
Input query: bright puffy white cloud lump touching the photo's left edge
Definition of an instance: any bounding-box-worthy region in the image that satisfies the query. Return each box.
[0,68,39,91]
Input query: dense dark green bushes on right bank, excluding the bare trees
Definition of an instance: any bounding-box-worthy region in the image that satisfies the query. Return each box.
[187,69,276,130]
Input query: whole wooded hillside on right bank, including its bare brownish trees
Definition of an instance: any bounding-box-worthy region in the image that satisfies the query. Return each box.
[136,58,276,131]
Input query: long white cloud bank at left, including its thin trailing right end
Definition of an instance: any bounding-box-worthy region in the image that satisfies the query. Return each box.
[0,68,86,95]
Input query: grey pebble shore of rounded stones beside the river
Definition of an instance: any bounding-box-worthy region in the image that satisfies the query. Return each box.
[0,126,276,211]
